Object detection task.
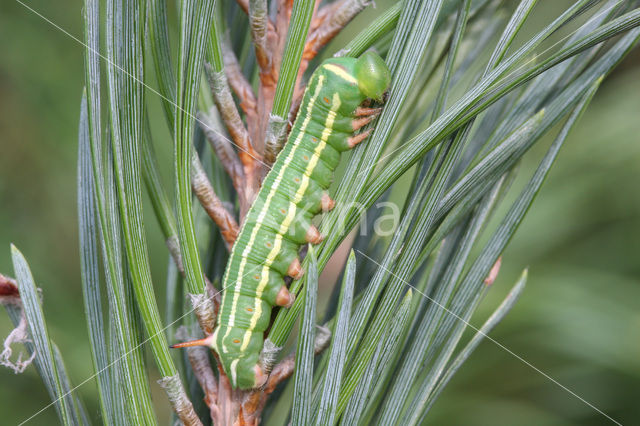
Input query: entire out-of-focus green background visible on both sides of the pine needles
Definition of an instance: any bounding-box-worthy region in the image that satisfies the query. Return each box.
[0,0,640,425]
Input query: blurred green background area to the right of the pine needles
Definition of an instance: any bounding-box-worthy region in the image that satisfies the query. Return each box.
[431,64,640,425]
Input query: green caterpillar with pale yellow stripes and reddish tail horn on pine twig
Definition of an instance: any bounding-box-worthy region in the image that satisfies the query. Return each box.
[174,52,390,389]
